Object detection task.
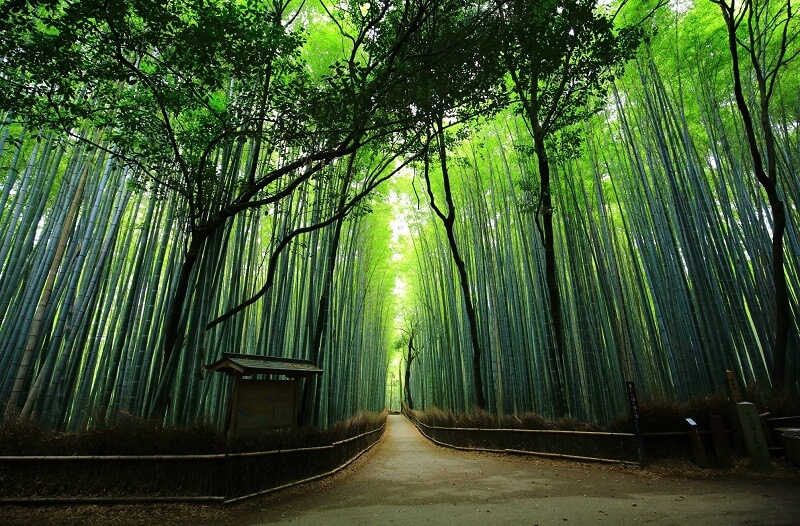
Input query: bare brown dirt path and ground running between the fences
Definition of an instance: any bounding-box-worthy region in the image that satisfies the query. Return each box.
[0,415,800,526]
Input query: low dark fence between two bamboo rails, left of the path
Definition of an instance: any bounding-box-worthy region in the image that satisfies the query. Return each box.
[0,423,386,504]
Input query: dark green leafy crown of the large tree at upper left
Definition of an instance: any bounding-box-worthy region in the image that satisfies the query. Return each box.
[0,0,325,208]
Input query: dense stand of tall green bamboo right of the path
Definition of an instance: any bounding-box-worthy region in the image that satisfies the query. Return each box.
[414,3,800,422]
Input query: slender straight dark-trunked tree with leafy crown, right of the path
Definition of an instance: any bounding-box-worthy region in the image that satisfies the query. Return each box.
[498,0,643,414]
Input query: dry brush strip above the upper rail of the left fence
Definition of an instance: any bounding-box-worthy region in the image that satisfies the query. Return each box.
[0,411,387,456]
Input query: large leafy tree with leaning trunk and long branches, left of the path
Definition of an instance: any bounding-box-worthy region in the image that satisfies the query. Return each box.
[0,0,432,421]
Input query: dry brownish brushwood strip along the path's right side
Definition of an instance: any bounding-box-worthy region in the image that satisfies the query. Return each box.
[411,389,800,433]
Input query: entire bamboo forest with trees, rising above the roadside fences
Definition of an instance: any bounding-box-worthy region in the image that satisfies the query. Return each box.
[0,0,800,434]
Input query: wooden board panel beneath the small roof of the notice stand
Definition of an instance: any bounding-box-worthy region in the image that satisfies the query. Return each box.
[232,379,299,433]
